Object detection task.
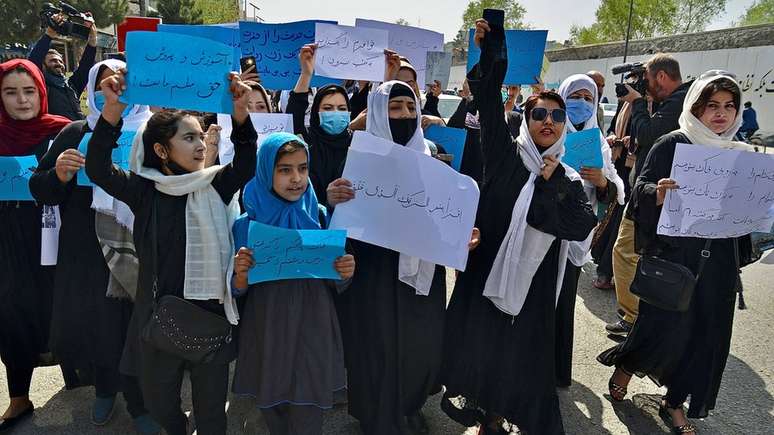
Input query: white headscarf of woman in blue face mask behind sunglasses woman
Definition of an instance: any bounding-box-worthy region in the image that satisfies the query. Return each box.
[559,74,626,267]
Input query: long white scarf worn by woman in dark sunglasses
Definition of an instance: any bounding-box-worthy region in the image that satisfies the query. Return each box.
[484,113,580,316]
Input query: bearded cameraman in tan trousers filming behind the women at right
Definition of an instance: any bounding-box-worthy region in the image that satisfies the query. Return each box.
[605,53,691,335]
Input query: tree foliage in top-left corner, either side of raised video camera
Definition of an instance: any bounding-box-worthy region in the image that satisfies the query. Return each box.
[0,0,128,44]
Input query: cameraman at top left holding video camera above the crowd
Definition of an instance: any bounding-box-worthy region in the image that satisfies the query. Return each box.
[29,15,97,121]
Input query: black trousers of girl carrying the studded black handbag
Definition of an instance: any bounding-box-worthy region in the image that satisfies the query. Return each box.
[140,343,228,435]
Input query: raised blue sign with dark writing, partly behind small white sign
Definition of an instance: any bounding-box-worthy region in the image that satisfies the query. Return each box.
[239,20,340,90]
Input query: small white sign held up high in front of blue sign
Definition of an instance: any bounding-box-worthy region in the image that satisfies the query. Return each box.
[314,23,387,82]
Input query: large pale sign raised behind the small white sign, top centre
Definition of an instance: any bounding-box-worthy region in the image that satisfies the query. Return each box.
[355,18,443,87]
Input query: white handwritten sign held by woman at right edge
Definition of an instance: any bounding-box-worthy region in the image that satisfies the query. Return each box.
[658,144,774,239]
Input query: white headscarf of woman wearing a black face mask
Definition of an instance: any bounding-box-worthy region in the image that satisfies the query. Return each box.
[366,80,435,296]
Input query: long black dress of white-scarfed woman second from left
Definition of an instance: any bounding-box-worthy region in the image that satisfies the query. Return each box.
[30,121,132,381]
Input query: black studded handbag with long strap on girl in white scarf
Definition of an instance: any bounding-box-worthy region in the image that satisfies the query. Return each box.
[142,198,233,364]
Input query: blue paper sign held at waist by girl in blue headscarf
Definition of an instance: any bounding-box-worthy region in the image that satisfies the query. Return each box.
[247,221,347,284]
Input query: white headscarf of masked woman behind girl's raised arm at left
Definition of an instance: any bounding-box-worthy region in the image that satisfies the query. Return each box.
[86,59,153,231]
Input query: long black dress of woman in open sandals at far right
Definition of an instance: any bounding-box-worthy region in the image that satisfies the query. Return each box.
[597,132,739,418]
